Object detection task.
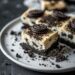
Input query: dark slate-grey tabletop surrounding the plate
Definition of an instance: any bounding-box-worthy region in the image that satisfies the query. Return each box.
[0,0,75,75]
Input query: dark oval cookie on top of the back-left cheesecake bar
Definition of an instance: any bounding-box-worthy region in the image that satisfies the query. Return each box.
[28,10,44,18]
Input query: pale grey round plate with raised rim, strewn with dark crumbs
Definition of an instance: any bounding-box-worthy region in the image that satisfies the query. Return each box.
[0,18,75,73]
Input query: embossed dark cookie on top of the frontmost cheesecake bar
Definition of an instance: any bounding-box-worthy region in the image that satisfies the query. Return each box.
[31,24,48,34]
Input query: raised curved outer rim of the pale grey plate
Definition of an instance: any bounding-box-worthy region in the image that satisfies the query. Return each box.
[0,17,75,73]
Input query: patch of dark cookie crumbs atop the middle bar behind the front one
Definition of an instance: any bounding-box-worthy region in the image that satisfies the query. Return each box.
[41,15,57,27]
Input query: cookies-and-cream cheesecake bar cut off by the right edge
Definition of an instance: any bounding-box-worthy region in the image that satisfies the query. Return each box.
[60,18,75,48]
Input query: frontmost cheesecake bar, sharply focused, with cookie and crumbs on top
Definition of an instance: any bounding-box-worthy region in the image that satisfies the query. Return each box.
[21,24,58,52]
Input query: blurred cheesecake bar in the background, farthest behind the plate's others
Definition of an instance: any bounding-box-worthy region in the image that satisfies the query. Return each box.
[41,0,67,11]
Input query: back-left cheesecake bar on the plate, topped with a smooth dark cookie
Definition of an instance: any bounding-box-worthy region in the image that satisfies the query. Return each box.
[21,8,44,26]
